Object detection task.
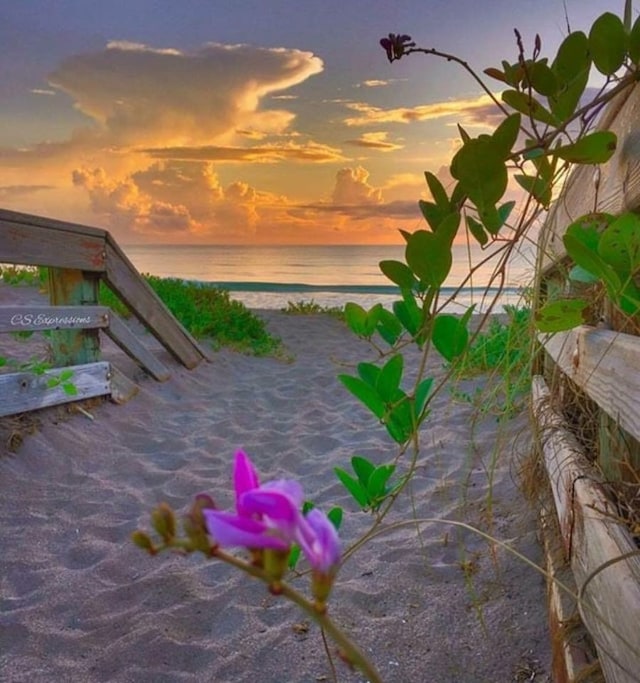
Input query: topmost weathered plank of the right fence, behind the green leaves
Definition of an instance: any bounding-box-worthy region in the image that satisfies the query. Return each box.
[538,86,640,271]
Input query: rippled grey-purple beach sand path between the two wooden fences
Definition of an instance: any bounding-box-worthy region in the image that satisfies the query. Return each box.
[0,288,550,683]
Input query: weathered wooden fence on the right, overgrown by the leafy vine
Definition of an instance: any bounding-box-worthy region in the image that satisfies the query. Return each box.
[533,87,640,683]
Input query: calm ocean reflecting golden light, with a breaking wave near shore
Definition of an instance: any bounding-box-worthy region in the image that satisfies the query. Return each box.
[123,245,534,312]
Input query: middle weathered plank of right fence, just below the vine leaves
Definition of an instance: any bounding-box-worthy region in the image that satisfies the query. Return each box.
[541,325,640,439]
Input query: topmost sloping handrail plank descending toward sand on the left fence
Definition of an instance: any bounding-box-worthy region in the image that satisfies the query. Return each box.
[106,237,206,368]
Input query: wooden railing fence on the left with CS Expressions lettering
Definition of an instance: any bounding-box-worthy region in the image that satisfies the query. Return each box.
[0,209,208,416]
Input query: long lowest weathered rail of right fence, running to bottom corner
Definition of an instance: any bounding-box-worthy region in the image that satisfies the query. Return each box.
[533,377,640,683]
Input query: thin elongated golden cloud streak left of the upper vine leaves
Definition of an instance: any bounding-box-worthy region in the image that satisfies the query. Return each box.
[344,95,496,126]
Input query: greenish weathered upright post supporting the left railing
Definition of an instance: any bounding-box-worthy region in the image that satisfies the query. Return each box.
[49,268,100,366]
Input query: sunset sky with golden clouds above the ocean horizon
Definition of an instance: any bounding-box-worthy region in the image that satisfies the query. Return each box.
[0,0,624,244]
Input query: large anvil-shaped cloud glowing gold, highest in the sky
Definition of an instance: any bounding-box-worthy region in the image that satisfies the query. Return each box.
[49,42,323,146]
